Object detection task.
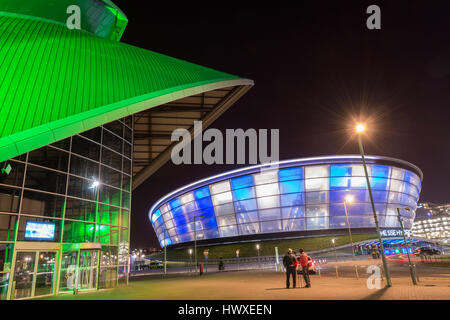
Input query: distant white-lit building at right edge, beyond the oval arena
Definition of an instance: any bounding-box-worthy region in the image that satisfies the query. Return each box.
[412,202,450,243]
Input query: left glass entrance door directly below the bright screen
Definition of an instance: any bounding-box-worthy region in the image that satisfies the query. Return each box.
[11,251,56,299]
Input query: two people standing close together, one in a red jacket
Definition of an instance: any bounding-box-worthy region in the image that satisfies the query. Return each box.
[283,248,311,289]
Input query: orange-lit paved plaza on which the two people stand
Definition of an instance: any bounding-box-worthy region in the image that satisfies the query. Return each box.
[42,260,450,300]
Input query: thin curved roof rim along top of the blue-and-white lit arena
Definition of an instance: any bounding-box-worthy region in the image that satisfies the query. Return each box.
[148,155,423,219]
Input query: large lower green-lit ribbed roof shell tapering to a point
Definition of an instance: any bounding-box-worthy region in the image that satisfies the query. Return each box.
[0,12,253,161]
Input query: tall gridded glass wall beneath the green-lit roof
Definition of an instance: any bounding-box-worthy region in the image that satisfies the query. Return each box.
[0,117,133,299]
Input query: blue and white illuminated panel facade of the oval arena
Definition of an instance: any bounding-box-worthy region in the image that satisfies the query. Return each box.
[149,155,423,246]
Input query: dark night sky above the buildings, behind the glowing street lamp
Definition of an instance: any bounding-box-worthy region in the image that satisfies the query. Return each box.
[115,0,450,247]
